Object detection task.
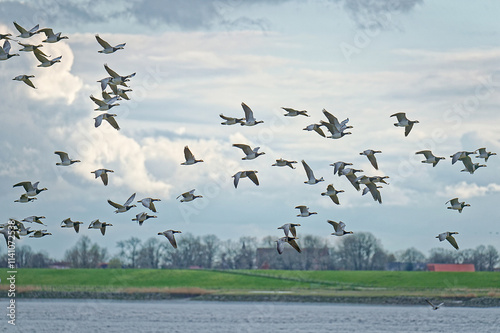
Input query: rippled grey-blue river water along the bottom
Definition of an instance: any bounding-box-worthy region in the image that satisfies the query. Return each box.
[0,299,500,333]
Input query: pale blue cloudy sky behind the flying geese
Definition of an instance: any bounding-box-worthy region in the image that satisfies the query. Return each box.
[0,0,500,259]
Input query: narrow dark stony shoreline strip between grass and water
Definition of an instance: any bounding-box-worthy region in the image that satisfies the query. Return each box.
[2,290,500,308]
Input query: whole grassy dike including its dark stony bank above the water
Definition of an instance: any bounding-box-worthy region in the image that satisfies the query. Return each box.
[0,269,500,306]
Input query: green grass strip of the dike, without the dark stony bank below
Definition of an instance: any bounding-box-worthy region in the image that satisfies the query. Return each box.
[0,269,500,298]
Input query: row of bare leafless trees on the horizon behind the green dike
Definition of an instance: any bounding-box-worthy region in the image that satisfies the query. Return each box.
[0,232,500,271]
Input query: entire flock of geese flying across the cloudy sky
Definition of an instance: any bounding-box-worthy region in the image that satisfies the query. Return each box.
[0,22,496,262]
